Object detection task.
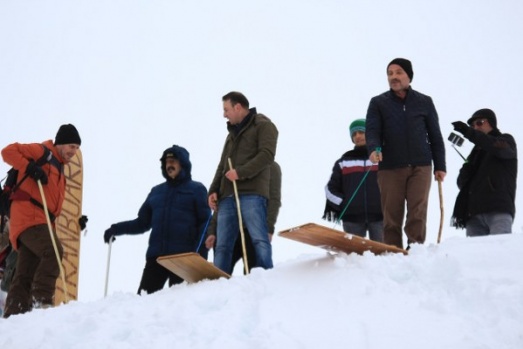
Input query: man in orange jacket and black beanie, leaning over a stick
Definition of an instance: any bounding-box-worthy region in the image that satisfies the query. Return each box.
[2,124,81,318]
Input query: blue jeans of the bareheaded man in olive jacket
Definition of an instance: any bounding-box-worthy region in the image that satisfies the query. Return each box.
[214,195,272,274]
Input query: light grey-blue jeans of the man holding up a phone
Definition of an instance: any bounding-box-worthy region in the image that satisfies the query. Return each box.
[465,212,514,236]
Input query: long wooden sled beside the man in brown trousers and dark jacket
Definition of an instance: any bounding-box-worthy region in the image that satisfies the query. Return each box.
[278,223,408,255]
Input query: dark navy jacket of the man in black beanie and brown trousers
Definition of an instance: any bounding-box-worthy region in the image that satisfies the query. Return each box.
[365,88,447,172]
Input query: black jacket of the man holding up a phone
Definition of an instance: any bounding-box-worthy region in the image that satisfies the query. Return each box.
[452,129,518,228]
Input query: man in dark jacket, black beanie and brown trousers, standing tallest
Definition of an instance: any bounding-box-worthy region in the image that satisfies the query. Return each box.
[366,58,446,248]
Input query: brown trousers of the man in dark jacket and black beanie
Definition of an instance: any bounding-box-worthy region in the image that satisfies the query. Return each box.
[378,166,432,248]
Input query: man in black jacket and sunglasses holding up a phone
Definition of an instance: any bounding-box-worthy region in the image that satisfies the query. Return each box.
[452,109,518,236]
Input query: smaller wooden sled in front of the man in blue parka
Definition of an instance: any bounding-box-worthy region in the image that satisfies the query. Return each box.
[156,252,231,284]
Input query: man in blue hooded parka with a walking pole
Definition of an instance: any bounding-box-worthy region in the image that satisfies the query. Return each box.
[104,145,211,294]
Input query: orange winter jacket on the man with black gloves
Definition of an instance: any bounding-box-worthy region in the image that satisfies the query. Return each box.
[2,140,65,249]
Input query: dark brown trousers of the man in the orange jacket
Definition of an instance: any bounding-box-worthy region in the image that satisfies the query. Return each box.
[4,224,63,318]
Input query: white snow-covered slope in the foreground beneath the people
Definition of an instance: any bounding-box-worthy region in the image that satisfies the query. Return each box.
[0,234,523,349]
